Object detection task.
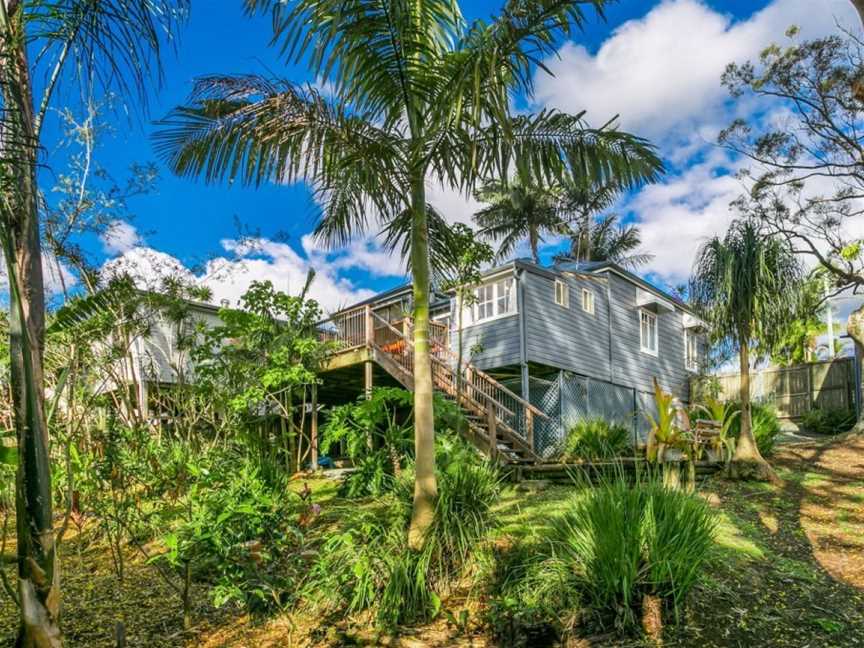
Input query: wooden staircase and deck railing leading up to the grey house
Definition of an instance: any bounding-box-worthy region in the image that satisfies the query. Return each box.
[320,305,548,464]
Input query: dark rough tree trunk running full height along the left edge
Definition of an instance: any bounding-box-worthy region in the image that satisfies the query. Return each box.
[0,7,62,648]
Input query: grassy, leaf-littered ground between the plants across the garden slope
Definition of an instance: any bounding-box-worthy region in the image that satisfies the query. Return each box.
[0,437,864,648]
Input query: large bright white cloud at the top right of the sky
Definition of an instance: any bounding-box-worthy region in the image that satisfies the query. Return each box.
[535,0,859,141]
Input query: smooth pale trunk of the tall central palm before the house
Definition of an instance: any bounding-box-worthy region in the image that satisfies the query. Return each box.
[408,173,438,550]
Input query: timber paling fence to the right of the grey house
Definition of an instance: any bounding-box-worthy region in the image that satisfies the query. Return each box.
[704,358,860,421]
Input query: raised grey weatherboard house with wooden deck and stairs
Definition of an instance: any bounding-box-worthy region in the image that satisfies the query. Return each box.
[319,259,705,462]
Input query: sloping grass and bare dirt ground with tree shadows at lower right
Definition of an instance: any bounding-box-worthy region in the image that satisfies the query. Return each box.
[670,436,864,648]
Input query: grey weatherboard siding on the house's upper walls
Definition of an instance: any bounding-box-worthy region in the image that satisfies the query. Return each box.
[453,266,691,401]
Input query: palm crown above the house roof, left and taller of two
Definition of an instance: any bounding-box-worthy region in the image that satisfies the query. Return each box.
[474,179,568,264]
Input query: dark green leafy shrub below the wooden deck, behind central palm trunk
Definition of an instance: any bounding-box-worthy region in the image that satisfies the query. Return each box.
[320,387,461,497]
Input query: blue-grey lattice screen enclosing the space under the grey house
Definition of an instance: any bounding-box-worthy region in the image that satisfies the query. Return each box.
[508,371,656,459]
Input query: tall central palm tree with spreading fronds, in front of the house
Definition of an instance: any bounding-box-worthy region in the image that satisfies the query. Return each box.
[157,0,662,548]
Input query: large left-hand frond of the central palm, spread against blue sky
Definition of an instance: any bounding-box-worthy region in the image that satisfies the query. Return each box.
[154,75,401,191]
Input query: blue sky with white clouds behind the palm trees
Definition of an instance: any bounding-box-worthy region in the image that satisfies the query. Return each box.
[37,0,856,334]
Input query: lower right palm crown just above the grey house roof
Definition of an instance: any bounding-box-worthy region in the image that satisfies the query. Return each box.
[555,214,654,270]
